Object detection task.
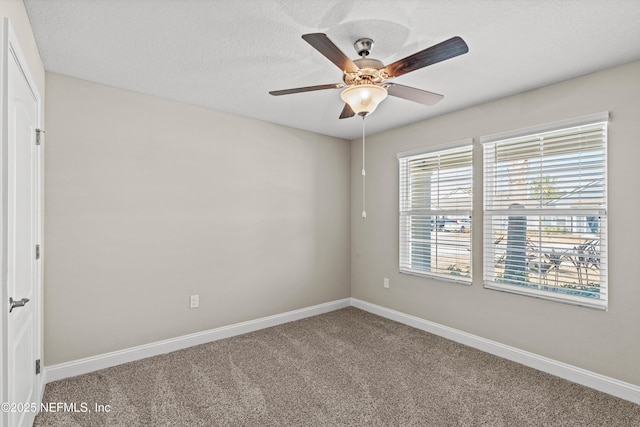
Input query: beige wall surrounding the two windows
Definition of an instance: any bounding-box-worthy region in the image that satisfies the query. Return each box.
[351,62,640,385]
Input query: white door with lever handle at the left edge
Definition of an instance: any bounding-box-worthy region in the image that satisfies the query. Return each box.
[3,21,41,427]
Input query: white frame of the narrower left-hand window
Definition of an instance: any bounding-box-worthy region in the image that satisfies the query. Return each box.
[396,138,474,285]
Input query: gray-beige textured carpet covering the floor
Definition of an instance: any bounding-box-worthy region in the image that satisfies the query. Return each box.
[35,307,640,426]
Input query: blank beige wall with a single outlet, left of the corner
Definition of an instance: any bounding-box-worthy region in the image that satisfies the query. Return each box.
[45,74,350,365]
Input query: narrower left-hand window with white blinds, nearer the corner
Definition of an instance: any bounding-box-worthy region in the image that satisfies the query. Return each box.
[398,139,473,283]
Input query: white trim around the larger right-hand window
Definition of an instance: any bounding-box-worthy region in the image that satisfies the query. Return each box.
[480,111,610,310]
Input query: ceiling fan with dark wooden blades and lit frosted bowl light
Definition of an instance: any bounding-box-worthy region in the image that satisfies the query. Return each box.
[269,33,469,119]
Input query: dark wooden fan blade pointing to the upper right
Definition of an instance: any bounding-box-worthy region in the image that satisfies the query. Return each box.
[384,36,469,77]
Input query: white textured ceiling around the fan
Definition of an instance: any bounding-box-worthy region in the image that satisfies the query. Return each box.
[25,0,640,139]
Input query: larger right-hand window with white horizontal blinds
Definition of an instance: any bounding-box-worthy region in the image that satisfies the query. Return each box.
[481,113,608,309]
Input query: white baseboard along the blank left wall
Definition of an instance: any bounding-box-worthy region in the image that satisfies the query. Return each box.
[43,298,351,383]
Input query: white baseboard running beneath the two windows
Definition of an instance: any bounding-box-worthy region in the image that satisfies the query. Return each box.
[351,298,640,404]
